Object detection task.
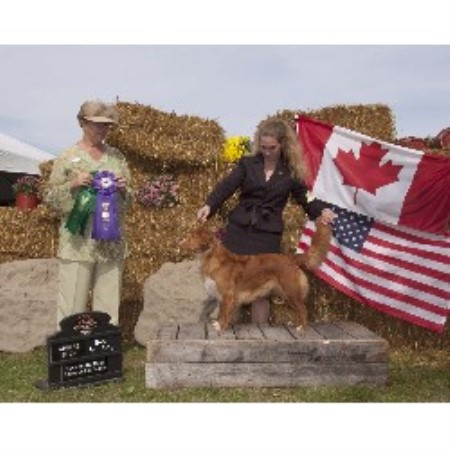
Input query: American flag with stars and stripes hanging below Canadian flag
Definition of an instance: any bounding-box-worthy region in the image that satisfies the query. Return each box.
[298,206,450,332]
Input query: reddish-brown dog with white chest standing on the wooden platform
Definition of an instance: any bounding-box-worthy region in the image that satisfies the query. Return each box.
[181,219,331,331]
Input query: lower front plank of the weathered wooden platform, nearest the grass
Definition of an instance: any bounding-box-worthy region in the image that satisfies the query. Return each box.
[145,363,387,389]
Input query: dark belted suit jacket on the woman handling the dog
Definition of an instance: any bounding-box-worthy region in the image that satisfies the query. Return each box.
[206,154,328,233]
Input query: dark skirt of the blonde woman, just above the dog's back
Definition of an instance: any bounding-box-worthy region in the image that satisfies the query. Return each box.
[222,222,282,255]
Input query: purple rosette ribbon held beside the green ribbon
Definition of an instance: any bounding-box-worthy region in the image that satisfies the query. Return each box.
[92,170,120,241]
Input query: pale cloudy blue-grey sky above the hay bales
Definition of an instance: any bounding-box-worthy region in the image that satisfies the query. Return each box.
[0,45,450,154]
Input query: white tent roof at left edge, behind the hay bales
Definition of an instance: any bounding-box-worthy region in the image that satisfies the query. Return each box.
[0,133,56,175]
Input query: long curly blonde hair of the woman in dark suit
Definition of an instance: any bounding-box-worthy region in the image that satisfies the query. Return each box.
[252,117,308,180]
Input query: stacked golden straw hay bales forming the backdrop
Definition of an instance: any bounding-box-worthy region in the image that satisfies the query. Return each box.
[0,102,450,347]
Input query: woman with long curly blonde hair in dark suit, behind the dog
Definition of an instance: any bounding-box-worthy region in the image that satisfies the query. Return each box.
[197,118,335,323]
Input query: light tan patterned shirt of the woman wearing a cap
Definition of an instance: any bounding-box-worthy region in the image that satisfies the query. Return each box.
[45,146,132,262]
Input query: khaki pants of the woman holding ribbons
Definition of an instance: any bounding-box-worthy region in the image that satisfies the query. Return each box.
[56,259,123,328]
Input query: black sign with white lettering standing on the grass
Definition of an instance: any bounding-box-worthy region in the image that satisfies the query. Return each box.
[36,311,122,389]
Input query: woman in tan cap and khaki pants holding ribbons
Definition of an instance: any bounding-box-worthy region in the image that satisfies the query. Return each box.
[45,101,131,325]
